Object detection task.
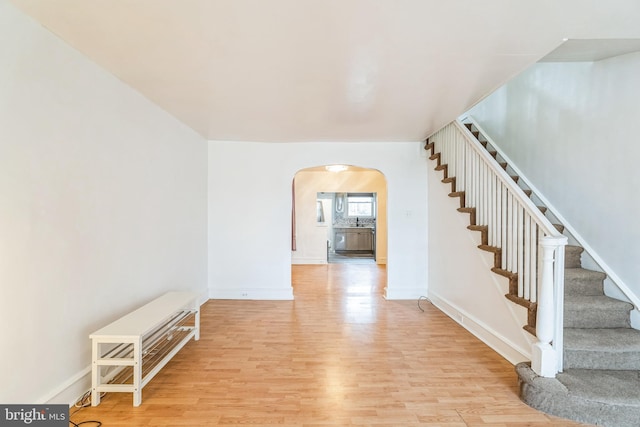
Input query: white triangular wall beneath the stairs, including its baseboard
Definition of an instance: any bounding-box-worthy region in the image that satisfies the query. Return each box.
[428,162,534,364]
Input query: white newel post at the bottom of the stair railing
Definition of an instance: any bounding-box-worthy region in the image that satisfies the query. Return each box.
[531,236,567,378]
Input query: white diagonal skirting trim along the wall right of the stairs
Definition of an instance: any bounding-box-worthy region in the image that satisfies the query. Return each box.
[462,115,640,311]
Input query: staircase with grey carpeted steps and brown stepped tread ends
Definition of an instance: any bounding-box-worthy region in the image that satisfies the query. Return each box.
[425,119,640,427]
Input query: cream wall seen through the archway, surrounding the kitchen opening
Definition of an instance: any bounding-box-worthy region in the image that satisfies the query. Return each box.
[291,170,387,264]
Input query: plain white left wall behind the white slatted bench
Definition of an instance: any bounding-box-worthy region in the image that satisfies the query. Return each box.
[0,0,207,403]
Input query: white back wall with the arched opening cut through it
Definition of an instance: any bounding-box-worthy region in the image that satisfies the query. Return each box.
[209,141,427,299]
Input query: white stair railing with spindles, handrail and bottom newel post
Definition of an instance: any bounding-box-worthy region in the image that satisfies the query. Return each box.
[429,120,567,377]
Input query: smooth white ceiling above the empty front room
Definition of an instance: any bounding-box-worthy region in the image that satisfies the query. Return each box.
[12,0,640,141]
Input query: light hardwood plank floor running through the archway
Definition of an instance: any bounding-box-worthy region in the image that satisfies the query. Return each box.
[71,264,592,427]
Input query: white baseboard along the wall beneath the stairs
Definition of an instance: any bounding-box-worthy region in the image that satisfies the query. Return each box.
[429,294,531,365]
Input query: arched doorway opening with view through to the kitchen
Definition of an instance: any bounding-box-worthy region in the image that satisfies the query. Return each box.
[291,165,387,264]
